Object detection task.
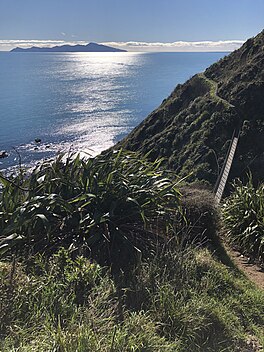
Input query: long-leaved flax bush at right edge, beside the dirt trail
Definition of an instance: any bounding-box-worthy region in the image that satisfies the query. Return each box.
[223,176,264,262]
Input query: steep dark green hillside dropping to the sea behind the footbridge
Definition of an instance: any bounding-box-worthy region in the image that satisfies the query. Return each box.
[118,31,264,185]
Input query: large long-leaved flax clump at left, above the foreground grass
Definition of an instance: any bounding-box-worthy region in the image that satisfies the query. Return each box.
[0,150,183,267]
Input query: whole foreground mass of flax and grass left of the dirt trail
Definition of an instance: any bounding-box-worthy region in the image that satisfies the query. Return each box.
[0,151,264,352]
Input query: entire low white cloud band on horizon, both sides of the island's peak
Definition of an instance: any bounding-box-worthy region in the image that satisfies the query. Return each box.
[0,39,244,52]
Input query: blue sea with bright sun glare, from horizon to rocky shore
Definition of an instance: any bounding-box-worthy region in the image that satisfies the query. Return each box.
[0,52,226,170]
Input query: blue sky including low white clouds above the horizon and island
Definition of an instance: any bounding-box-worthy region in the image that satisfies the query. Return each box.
[0,0,264,51]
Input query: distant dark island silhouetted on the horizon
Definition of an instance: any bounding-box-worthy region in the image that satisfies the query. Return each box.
[11,43,126,53]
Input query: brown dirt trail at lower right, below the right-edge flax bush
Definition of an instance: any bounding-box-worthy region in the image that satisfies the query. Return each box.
[227,248,264,290]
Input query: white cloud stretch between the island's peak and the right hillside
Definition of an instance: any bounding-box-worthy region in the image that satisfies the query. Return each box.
[102,40,245,52]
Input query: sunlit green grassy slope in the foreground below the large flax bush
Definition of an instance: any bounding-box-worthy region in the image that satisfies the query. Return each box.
[0,248,264,352]
